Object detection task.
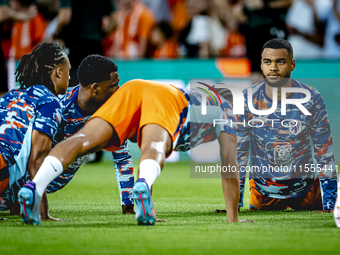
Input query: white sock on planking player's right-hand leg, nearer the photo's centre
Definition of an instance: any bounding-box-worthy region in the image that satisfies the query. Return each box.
[139,159,161,189]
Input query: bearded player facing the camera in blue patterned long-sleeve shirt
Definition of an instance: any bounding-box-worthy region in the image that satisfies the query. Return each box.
[237,39,337,212]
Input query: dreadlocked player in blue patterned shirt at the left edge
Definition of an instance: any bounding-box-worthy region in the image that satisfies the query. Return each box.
[0,43,71,219]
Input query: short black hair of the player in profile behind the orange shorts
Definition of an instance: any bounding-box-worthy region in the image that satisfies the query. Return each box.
[77,54,118,87]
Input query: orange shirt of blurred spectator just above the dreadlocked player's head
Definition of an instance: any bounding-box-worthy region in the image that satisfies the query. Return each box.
[9,13,46,60]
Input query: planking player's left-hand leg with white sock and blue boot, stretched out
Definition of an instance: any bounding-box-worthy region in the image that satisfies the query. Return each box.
[19,118,114,224]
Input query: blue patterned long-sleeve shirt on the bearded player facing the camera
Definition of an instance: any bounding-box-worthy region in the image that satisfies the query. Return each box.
[237,80,337,210]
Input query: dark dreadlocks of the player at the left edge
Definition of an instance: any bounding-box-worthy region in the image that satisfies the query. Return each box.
[15,43,66,95]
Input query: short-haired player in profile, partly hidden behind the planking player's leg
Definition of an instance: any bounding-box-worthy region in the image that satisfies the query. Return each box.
[46,55,134,214]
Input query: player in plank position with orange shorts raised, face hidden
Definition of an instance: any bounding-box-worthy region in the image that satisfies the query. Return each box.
[19,56,252,225]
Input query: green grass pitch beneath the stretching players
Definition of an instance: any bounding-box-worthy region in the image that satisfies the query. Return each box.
[0,162,340,255]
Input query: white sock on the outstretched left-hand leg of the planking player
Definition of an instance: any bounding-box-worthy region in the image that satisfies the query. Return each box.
[33,156,64,196]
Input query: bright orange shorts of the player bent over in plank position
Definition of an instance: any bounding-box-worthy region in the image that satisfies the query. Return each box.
[92,80,188,151]
